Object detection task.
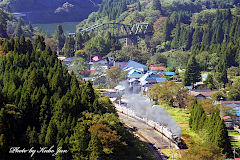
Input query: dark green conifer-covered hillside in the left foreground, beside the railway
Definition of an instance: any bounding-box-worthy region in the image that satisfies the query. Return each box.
[0,36,154,160]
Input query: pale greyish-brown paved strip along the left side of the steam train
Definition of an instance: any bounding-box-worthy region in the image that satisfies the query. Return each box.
[118,112,170,159]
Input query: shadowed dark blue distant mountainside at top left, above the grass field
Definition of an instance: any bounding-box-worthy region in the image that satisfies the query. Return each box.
[0,0,101,23]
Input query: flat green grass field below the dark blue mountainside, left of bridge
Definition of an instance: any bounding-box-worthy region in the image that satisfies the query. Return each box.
[33,22,80,34]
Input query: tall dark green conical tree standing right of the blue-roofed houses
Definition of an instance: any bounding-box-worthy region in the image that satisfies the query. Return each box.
[183,56,201,86]
